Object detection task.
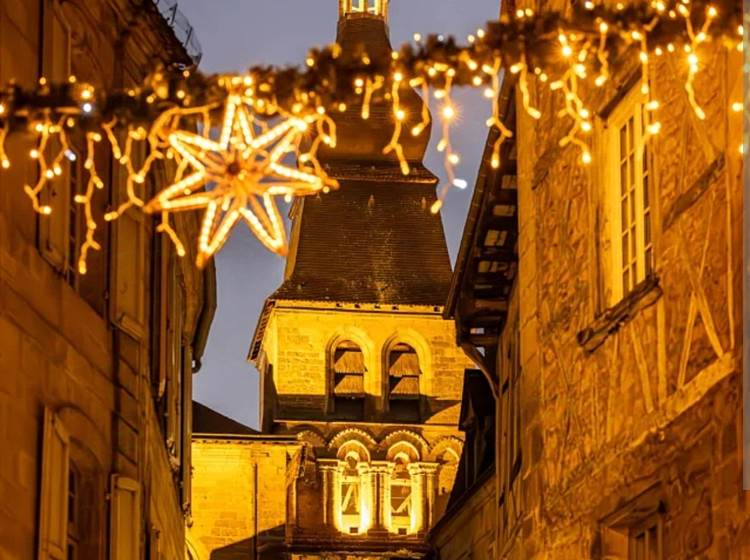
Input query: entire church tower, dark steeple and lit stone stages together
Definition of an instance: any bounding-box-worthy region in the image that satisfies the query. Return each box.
[250,0,468,558]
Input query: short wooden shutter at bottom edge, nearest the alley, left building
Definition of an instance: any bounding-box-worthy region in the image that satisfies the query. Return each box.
[109,474,141,560]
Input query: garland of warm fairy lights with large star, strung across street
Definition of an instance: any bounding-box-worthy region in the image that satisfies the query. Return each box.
[0,0,743,273]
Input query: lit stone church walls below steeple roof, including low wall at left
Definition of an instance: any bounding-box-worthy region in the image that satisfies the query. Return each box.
[189,301,468,560]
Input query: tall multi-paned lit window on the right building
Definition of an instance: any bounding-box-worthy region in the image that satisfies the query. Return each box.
[607,84,654,303]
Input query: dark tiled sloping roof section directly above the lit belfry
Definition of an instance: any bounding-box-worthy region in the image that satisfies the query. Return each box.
[271,176,451,306]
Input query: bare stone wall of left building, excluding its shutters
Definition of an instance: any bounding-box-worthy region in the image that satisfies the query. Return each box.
[0,0,209,559]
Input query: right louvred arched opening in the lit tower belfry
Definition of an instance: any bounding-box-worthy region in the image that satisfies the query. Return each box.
[386,343,421,422]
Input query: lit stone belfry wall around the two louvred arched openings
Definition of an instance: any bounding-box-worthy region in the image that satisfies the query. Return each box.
[263,302,469,425]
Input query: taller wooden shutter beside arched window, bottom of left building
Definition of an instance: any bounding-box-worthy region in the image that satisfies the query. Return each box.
[39,409,70,560]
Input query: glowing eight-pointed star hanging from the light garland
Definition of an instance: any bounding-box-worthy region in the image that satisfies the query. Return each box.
[146,93,336,267]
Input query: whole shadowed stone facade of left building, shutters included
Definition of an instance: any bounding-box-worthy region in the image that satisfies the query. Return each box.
[0,0,214,560]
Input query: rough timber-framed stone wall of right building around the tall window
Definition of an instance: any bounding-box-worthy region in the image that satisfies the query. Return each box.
[516,1,750,559]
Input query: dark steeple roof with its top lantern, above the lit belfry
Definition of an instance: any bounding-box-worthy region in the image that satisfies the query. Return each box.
[271,0,451,306]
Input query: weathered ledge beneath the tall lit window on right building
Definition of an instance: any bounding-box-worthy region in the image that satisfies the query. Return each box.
[576,275,662,353]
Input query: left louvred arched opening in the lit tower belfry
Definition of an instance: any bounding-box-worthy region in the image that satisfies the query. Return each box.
[330,340,366,420]
